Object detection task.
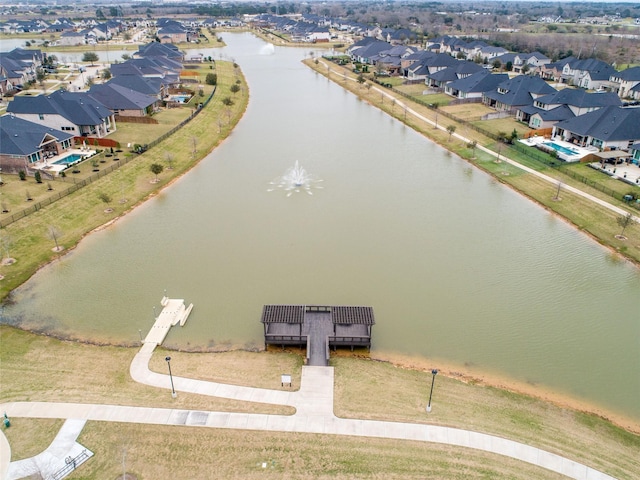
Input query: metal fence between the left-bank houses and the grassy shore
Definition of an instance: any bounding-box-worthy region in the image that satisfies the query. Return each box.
[0,86,216,228]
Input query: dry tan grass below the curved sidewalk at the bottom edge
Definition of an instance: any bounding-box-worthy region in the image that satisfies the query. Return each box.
[68,422,564,480]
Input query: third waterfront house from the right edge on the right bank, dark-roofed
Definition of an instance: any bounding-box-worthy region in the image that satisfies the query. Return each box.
[482,75,556,114]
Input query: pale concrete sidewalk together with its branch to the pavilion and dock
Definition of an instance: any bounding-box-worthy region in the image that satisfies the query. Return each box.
[0,343,614,480]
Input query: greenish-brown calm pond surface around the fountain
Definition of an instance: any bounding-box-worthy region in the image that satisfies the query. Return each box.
[3,34,640,419]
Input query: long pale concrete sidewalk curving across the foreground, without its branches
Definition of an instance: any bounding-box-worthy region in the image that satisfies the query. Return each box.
[0,400,614,480]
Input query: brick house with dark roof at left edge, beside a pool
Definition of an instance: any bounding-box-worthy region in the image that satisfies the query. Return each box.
[0,114,74,172]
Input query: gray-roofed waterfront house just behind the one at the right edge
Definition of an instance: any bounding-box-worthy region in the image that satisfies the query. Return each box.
[516,88,622,129]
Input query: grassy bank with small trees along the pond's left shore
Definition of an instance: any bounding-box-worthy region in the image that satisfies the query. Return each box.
[0,61,248,298]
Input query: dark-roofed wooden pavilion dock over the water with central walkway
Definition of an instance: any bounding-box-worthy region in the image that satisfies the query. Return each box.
[261,305,375,366]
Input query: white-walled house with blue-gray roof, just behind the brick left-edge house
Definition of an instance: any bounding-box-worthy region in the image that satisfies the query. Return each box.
[7,90,116,138]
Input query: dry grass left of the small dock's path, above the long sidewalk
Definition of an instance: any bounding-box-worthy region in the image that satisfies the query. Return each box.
[0,326,293,414]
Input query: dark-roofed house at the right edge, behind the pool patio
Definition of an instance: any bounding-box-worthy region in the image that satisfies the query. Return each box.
[553,106,640,151]
